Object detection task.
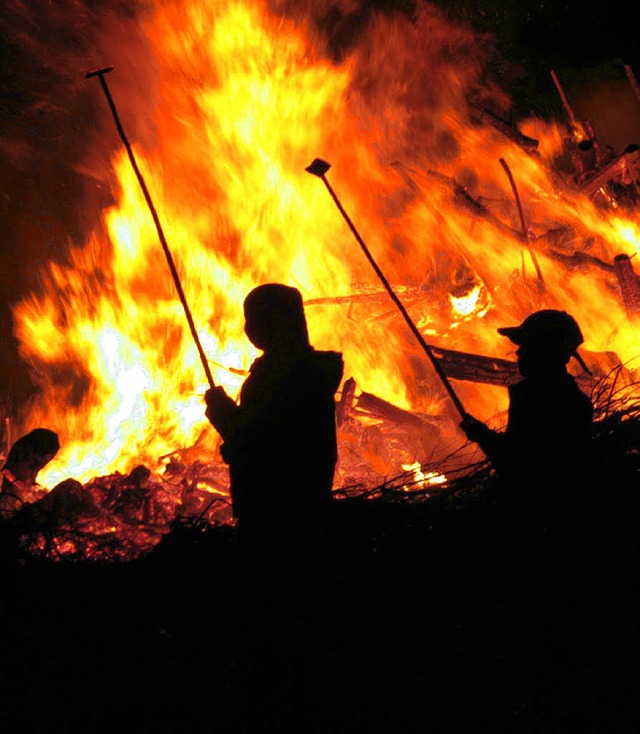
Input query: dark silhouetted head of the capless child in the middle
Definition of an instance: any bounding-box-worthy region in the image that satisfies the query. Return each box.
[244,283,309,353]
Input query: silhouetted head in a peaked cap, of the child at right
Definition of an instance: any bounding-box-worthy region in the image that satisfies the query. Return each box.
[498,309,587,377]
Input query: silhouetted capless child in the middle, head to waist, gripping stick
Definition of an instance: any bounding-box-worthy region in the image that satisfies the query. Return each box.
[205,283,343,548]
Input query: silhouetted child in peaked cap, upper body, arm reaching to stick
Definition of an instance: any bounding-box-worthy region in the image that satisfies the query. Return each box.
[460,309,593,501]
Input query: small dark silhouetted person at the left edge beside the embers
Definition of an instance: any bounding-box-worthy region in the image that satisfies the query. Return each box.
[0,428,60,520]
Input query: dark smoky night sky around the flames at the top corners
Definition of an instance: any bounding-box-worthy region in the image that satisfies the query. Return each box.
[0,0,640,412]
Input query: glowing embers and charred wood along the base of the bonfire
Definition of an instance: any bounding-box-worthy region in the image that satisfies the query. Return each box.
[3,355,640,562]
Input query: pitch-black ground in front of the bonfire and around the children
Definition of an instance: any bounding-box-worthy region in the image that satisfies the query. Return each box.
[0,500,640,734]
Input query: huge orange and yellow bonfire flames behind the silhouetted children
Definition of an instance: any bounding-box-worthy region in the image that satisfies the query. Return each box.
[3,0,640,560]
